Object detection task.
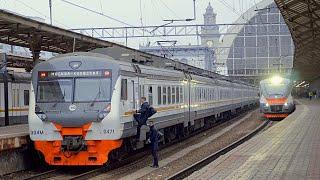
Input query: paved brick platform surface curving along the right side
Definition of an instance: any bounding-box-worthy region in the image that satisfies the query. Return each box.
[187,100,320,180]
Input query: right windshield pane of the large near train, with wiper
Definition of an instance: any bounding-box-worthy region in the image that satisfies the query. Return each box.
[74,78,111,102]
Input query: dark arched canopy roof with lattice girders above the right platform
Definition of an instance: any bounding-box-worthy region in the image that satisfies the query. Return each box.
[275,0,320,81]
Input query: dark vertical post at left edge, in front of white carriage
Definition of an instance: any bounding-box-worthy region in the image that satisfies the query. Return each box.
[0,53,10,126]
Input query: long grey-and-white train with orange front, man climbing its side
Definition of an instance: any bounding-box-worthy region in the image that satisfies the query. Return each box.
[28,53,258,166]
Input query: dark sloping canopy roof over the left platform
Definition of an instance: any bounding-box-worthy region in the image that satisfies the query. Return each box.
[0,10,114,53]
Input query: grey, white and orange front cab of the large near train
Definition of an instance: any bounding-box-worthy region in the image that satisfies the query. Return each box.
[28,54,122,166]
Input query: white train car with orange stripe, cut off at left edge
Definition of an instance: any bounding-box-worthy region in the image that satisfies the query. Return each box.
[0,71,31,126]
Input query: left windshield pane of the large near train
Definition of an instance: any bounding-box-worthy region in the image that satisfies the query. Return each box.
[37,79,72,102]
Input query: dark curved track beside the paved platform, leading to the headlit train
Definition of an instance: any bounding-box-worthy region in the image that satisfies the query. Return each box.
[167,120,270,180]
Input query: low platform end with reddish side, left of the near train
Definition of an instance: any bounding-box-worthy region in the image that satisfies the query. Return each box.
[0,124,29,151]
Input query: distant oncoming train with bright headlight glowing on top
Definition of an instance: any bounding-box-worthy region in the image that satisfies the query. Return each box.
[260,76,295,118]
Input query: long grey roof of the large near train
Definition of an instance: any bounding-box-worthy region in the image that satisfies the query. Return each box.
[42,51,256,87]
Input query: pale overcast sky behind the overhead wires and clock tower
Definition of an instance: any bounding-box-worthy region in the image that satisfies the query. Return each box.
[0,0,260,46]
